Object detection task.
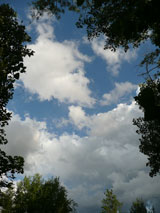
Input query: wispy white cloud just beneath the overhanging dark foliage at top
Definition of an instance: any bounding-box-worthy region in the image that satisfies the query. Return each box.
[91,39,137,76]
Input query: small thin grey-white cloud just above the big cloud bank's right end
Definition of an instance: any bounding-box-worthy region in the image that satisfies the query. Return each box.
[101,82,137,105]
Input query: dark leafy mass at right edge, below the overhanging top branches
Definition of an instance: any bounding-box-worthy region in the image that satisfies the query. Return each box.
[133,76,160,177]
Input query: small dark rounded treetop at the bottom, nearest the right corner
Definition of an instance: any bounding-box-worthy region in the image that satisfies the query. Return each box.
[130,199,147,213]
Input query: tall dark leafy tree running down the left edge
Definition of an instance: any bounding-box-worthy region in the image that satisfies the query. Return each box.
[0,4,33,187]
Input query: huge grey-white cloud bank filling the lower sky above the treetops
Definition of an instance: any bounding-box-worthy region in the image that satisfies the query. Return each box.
[5,103,160,213]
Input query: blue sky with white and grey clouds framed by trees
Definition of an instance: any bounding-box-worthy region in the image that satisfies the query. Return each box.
[3,0,160,213]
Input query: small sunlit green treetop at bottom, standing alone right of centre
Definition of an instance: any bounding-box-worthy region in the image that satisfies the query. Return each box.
[102,189,122,213]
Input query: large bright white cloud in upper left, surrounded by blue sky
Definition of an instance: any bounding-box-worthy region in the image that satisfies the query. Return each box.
[21,19,95,107]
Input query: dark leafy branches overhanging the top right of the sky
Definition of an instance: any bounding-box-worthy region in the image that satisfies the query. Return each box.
[33,0,160,50]
